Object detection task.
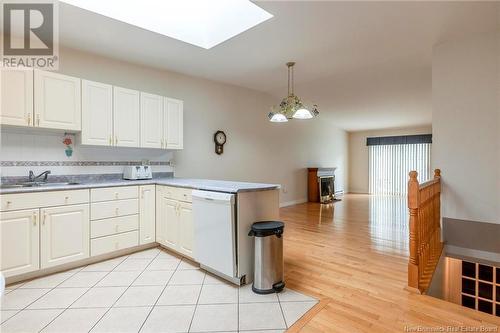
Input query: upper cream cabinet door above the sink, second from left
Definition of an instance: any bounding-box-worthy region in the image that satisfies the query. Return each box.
[34,71,82,131]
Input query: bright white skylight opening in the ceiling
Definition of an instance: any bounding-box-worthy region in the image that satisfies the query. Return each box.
[62,0,273,49]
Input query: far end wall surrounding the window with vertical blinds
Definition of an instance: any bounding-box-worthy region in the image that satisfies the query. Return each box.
[349,126,432,193]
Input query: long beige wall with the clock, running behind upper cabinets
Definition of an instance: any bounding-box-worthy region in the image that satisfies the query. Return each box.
[2,49,347,203]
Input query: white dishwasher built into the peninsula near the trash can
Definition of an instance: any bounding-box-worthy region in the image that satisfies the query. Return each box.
[192,190,237,280]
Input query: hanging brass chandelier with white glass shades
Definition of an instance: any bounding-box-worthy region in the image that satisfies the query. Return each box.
[268,62,319,123]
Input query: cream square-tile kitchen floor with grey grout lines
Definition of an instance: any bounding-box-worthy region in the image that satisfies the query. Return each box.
[0,248,317,333]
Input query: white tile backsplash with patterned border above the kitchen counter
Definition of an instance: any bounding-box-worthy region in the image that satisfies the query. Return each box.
[0,128,173,177]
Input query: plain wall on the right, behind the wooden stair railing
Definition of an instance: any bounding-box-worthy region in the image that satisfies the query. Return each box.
[432,32,500,223]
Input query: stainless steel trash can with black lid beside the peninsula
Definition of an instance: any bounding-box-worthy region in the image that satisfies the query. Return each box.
[248,221,285,294]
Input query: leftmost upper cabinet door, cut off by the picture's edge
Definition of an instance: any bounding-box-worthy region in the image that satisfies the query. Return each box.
[0,69,33,126]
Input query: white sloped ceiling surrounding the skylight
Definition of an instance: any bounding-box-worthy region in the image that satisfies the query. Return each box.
[59,1,499,130]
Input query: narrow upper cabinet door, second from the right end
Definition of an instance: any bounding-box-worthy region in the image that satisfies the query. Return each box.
[141,92,163,148]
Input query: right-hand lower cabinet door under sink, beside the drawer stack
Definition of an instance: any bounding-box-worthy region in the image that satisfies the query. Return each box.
[40,204,90,268]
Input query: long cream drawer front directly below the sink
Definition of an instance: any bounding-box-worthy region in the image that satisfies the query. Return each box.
[0,190,89,211]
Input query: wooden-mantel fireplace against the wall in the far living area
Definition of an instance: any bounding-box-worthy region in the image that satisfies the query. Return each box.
[308,168,337,203]
